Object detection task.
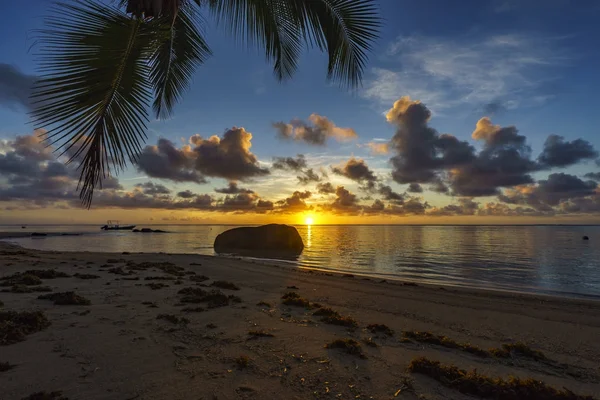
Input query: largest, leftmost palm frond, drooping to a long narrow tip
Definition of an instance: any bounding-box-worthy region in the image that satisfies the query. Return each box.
[32,0,151,207]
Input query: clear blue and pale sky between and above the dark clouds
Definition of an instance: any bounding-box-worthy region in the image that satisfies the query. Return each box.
[0,0,600,223]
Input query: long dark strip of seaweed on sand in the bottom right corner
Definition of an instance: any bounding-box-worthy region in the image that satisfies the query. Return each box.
[408,357,593,400]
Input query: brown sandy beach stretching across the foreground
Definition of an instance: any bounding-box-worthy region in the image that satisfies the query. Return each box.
[0,239,600,400]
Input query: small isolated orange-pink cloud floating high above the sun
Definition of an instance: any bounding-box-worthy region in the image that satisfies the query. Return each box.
[273,114,358,146]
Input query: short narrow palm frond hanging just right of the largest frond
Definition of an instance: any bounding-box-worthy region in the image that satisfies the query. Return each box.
[150,6,212,118]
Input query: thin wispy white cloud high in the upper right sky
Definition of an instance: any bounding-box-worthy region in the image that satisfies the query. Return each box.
[362,34,568,112]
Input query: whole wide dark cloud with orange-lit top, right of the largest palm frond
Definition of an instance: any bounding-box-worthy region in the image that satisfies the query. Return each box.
[137,128,269,183]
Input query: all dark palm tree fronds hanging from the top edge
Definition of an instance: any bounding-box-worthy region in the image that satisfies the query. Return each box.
[32,0,381,207]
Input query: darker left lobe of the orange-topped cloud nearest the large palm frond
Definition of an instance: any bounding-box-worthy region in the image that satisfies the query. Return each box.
[137,139,206,183]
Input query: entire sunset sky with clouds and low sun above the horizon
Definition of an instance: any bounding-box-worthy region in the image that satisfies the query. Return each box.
[0,0,600,224]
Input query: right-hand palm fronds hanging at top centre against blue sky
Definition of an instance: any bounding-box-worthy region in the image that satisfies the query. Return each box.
[208,0,381,87]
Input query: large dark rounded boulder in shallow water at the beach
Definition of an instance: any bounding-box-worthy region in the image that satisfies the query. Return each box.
[214,224,304,254]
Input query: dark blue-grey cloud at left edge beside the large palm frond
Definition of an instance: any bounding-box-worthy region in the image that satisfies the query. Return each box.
[0,63,37,109]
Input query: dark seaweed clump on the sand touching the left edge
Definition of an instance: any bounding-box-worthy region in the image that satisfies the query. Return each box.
[0,311,50,346]
